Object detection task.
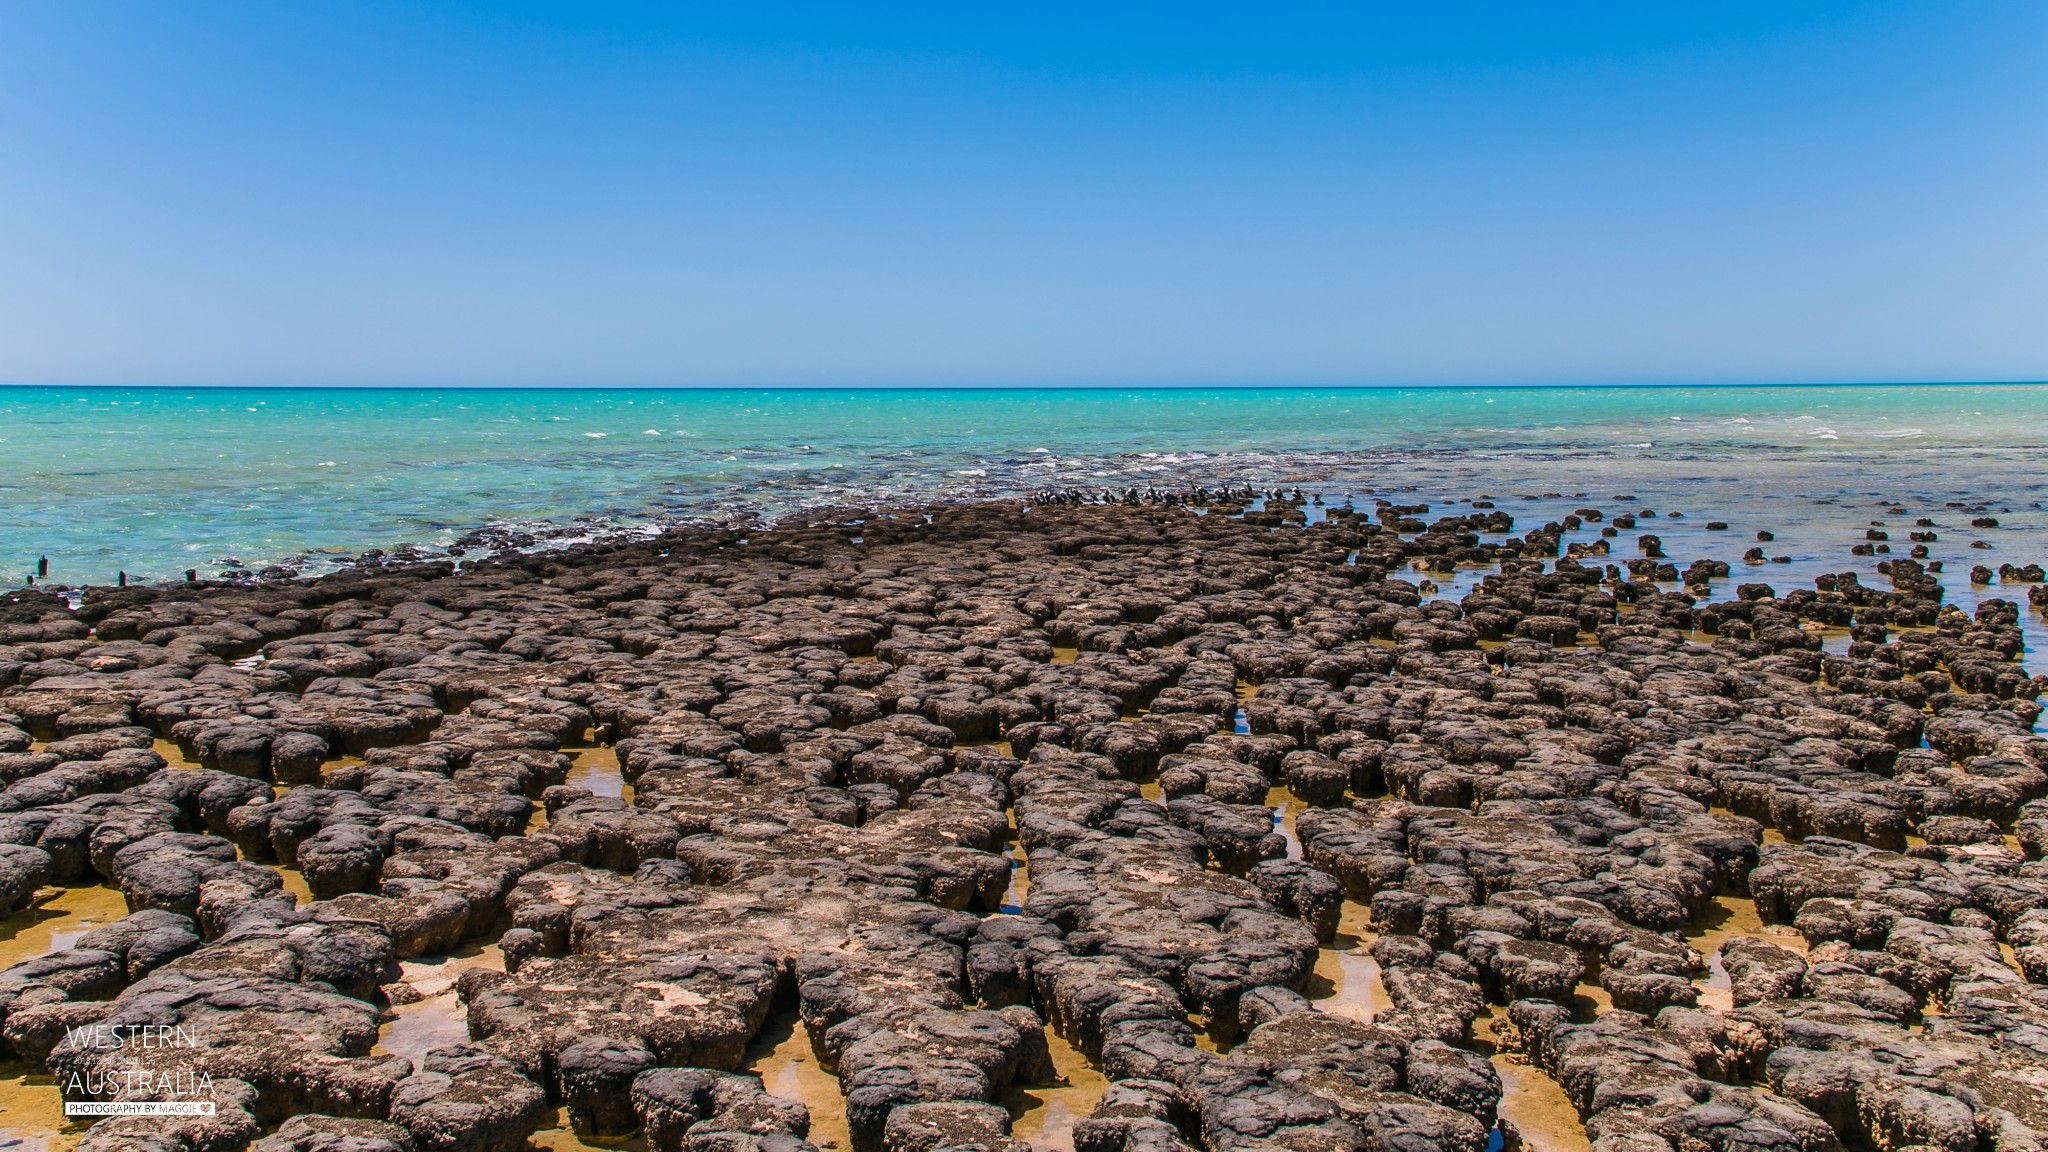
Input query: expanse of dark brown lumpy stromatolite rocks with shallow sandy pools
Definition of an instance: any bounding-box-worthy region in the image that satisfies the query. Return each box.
[0,498,2048,1152]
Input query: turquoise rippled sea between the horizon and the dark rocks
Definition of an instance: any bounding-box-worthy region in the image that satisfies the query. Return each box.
[0,385,2048,584]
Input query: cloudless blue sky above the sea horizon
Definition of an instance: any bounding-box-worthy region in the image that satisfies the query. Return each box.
[0,0,2048,385]
